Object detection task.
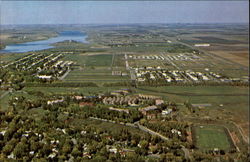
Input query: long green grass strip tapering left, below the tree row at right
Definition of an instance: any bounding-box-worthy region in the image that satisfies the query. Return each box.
[138,86,249,110]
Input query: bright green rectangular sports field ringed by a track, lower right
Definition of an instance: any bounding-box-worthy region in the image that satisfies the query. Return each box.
[193,125,232,151]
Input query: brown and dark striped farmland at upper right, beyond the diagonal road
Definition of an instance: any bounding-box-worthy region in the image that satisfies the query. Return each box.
[177,29,249,67]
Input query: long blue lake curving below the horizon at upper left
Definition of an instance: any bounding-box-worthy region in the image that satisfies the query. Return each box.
[0,31,88,53]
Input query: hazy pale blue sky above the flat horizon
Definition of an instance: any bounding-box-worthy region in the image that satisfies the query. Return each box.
[0,0,249,25]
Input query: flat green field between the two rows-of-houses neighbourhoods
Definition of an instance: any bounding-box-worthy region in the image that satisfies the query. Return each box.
[61,54,129,85]
